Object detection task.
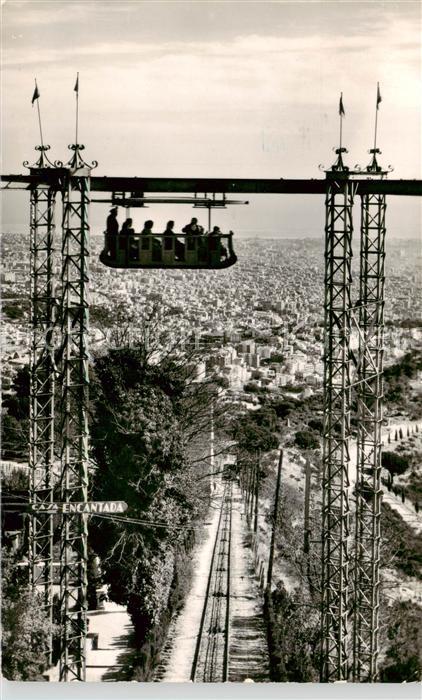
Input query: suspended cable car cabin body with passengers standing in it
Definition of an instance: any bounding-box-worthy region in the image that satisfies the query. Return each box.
[100,232,237,270]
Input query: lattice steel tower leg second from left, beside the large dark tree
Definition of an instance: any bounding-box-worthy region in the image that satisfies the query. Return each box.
[60,169,90,681]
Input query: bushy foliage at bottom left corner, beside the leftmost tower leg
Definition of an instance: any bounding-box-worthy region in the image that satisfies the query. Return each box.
[2,549,55,681]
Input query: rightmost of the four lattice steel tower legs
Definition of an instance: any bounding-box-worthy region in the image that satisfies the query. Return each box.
[353,194,386,683]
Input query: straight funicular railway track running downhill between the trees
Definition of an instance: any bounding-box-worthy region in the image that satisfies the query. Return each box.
[191,481,232,683]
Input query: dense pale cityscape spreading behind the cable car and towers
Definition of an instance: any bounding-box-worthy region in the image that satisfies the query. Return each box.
[2,233,422,392]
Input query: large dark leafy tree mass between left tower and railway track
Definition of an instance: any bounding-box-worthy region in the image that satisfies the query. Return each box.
[90,347,211,652]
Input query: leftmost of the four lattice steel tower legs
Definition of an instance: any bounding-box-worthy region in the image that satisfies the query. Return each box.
[29,186,56,665]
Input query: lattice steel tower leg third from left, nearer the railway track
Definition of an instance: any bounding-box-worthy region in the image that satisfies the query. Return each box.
[321,179,354,682]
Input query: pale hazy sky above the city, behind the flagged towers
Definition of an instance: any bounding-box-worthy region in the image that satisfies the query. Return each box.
[1,0,422,237]
